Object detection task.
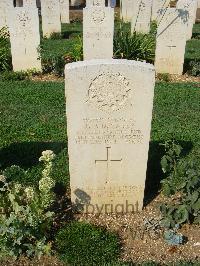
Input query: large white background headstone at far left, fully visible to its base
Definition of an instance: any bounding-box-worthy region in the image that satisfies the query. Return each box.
[9,7,41,71]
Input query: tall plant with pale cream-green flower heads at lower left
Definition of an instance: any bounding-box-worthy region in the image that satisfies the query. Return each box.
[0,151,55,259]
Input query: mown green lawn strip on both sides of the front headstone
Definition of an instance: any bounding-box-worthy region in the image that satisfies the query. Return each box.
[0,81,200,191]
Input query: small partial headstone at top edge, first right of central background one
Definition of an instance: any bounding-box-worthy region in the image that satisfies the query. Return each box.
[120,0,134,22]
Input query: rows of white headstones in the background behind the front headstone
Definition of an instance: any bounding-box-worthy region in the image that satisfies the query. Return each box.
[1,0,197,74]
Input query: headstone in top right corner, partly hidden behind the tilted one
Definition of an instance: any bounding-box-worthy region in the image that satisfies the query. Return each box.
[177,0,197,40]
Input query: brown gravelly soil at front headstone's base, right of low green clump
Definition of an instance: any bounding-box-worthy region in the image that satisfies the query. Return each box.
[79,195,200,263]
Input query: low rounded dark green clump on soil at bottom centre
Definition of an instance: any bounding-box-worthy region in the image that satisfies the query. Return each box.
[56,222,120,265]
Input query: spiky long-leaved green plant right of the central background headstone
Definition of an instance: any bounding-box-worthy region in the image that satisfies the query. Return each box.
[114,24,155,63]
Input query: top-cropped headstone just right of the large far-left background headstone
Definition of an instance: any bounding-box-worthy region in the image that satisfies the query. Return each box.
[41,0,61,37]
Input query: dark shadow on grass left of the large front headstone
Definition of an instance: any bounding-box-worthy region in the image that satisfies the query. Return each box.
[0,142,67,170]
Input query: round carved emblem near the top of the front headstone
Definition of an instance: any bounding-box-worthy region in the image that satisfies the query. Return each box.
[87,73,131,112]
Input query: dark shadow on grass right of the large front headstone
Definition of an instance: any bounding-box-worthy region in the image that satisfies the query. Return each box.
[144,141,193,206]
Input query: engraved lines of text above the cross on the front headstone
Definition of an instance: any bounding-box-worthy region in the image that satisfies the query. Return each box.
[75,118,143,145]
